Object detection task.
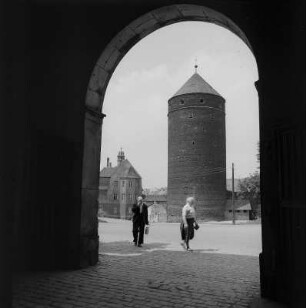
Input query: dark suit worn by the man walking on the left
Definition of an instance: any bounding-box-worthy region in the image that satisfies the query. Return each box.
[132,203,149,245]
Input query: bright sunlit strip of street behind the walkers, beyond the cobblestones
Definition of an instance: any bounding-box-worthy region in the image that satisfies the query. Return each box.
[99,218,261,257]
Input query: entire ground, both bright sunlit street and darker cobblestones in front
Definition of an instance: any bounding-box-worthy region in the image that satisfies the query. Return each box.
[13,219,261,308]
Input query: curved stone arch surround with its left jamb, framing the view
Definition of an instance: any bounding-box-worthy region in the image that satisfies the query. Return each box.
[80,4,252,266]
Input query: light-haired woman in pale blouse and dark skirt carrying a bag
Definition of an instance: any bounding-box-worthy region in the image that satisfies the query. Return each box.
[180,197,199,251]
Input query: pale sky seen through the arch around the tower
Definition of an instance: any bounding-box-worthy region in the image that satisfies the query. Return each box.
[100,22,259,189]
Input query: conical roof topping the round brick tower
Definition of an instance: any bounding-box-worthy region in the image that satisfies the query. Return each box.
[172,73,221,97]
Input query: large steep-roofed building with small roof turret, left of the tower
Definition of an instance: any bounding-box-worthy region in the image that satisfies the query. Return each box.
[99,150,142,219]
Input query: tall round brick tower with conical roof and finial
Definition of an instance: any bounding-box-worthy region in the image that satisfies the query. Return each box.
[167,66,226,221]
